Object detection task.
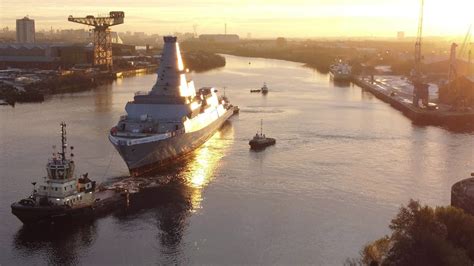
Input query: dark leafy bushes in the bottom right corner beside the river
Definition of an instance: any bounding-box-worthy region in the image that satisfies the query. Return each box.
[358,200,474,265]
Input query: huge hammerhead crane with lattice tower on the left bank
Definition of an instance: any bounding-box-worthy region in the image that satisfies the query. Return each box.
[67,11,125,69]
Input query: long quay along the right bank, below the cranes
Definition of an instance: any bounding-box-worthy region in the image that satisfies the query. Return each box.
[352,76,474,127]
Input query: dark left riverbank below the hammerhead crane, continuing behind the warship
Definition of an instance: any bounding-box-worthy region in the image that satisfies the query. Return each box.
[0,52,226,106]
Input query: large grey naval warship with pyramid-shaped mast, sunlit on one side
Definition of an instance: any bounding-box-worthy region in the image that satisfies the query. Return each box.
[109,36,234,176]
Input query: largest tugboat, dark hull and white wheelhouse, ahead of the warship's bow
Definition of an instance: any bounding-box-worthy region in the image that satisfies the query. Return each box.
[11,122,123,225]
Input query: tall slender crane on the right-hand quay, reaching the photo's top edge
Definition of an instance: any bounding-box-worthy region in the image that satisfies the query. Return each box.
[412,0,429,107]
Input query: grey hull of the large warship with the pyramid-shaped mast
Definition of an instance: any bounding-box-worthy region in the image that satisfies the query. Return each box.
[109,108,233,176]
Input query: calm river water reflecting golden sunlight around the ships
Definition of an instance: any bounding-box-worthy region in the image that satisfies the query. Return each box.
[0,56,474,265]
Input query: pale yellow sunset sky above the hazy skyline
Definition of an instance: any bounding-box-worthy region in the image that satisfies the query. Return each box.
[0,0,474,38]
